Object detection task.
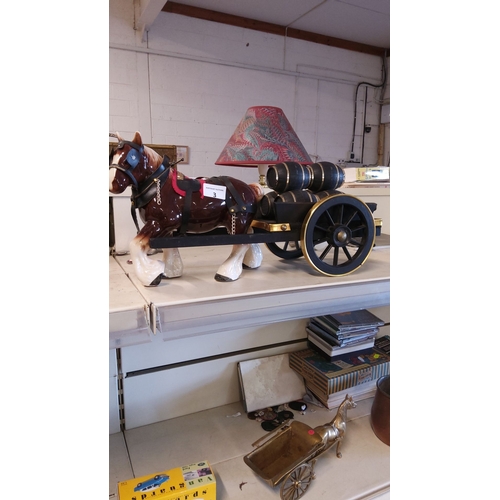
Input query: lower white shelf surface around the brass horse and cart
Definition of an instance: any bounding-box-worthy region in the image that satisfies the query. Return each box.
[114,399,390,500]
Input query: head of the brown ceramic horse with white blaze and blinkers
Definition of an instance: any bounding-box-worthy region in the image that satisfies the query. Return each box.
[109,132,161,194]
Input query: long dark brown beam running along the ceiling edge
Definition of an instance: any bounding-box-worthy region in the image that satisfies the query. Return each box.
[162,1,389,57]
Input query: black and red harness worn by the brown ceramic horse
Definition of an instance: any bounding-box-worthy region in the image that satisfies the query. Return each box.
[109,141,255,234]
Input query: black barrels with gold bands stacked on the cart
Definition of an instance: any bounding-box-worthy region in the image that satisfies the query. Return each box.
[260,161,345,218]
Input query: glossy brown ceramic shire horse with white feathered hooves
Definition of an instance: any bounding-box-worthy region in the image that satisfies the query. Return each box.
[109,132,264,286]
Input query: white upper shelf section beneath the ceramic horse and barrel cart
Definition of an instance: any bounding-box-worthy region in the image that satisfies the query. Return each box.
[116,245,390,340]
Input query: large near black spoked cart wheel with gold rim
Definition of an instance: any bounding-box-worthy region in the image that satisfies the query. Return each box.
[301,194,375,276]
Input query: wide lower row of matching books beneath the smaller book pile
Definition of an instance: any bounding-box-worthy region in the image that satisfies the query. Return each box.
[289,347,391,408]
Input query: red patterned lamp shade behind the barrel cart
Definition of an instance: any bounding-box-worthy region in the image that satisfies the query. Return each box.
[215,106,313,167]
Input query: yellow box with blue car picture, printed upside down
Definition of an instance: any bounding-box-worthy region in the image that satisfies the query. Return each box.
[118,460,216,500]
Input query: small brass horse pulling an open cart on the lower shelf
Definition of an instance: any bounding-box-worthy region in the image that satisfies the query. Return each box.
[243,395,356,500]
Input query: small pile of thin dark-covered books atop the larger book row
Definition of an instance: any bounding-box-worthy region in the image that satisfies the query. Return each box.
[306,309,384,361]
